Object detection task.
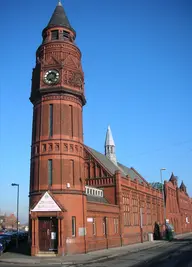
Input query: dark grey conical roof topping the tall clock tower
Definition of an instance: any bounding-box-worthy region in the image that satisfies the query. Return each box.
[47,1,74,31]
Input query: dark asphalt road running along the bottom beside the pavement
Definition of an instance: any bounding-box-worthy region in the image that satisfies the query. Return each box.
[0,236,192,267]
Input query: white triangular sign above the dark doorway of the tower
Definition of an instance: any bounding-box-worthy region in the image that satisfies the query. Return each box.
[32,192,61,211]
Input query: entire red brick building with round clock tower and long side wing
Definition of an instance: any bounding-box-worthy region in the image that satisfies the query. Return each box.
[29,1,191,255]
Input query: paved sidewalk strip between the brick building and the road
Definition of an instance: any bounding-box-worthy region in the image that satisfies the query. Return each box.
[0,233,192,266]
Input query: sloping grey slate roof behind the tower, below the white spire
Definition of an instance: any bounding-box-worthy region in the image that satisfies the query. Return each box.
[85,146,148,184]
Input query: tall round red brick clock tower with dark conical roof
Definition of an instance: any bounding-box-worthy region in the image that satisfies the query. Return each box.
[29,1,86,255]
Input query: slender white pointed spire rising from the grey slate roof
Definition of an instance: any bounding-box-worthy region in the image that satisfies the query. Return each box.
[105,126,117,164]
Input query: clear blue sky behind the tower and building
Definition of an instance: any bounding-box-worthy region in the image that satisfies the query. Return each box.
[0,0,192,222]
